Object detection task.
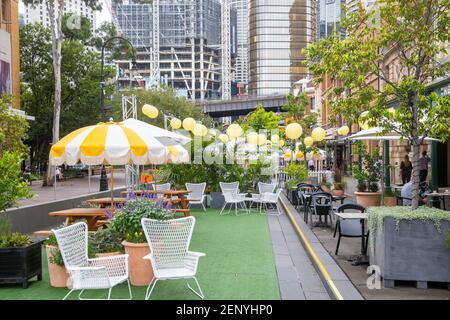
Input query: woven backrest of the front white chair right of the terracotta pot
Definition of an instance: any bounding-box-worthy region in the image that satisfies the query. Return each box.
[141,216,195,270]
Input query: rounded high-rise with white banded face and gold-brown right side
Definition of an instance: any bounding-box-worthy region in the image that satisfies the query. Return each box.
[248,0,317,96]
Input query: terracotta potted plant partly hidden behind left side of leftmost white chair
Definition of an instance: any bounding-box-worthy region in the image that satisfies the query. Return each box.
[44,233,69,288]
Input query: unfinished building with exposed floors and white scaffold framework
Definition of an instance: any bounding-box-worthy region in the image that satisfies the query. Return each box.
[112,0,236,99]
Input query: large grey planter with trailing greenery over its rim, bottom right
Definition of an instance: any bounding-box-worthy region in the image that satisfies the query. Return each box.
[367,207,450,288]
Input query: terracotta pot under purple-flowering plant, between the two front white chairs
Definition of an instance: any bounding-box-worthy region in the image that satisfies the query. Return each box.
[122,241,153,286]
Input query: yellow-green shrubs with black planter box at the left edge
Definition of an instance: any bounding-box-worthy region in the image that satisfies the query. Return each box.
[0,151,37,288]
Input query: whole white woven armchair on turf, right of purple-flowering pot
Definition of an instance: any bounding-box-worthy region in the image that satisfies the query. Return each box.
[141,216,206,300]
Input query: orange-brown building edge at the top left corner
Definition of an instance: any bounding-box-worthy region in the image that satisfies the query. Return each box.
[0,0,20,107]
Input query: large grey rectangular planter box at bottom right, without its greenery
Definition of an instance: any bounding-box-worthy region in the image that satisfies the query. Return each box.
[368,217,450,289]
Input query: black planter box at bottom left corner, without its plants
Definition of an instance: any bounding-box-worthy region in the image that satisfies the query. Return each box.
[0,242,42,289]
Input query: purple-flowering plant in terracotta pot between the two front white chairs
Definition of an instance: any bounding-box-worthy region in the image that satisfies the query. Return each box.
[110,198,171,286]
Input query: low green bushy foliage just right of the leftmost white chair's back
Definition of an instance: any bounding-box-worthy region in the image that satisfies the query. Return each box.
[89,228,124,258]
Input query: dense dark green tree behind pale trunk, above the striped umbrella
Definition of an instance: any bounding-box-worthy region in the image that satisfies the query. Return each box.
[20,24,114,176]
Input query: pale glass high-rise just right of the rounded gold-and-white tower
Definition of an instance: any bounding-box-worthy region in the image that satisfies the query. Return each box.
[317,0,345,39]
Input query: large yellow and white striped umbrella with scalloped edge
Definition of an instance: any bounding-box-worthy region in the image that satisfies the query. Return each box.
[50,119,191,165]
